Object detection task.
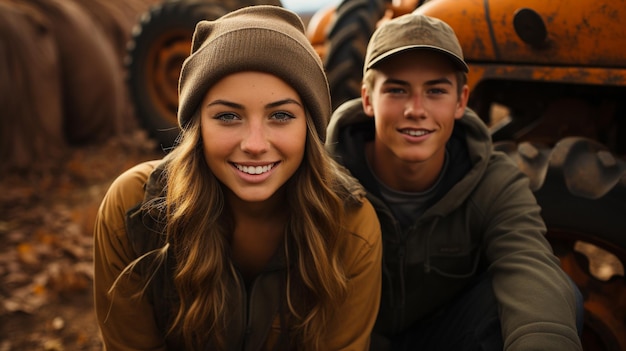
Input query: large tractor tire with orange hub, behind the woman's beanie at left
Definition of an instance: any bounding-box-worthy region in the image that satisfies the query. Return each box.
[126,0,281,150]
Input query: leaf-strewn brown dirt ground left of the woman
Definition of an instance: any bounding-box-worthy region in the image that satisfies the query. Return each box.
[0,131,163,351]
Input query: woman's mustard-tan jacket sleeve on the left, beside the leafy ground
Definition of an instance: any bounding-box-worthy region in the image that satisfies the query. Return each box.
[94,161,165,351]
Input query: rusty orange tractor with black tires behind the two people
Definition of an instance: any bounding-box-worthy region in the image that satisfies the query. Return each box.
[128,0,626,350]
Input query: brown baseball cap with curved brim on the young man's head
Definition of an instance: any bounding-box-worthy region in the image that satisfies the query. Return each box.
[363,13,469,73]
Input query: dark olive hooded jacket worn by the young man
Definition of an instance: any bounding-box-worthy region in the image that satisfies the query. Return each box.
[326,99,581,350]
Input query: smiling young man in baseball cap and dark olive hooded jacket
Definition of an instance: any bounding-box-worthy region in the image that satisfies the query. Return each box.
[326,14,582,351]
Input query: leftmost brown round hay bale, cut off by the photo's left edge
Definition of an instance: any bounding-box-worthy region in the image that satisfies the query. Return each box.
[0,0,66,171]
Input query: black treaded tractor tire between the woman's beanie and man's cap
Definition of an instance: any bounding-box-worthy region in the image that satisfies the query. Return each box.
[324,0,386,110]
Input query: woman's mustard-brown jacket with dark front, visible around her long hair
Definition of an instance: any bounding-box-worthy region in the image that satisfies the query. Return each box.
[94,161,382,351]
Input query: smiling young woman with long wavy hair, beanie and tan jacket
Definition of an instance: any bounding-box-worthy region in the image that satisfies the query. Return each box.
[94,6,382,350]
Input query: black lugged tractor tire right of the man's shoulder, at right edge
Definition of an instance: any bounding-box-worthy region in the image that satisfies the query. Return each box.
[495,137,626,256]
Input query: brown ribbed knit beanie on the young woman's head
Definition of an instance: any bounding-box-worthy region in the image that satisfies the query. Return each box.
[178,5,331,142]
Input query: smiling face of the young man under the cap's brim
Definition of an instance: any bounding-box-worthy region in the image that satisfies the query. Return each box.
[361,50,469,171]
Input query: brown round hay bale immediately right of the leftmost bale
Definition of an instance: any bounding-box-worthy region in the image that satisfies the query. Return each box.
[30,0,129,144]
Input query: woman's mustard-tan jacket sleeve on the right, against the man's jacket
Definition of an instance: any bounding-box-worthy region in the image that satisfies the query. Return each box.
[328,200,382,351]
